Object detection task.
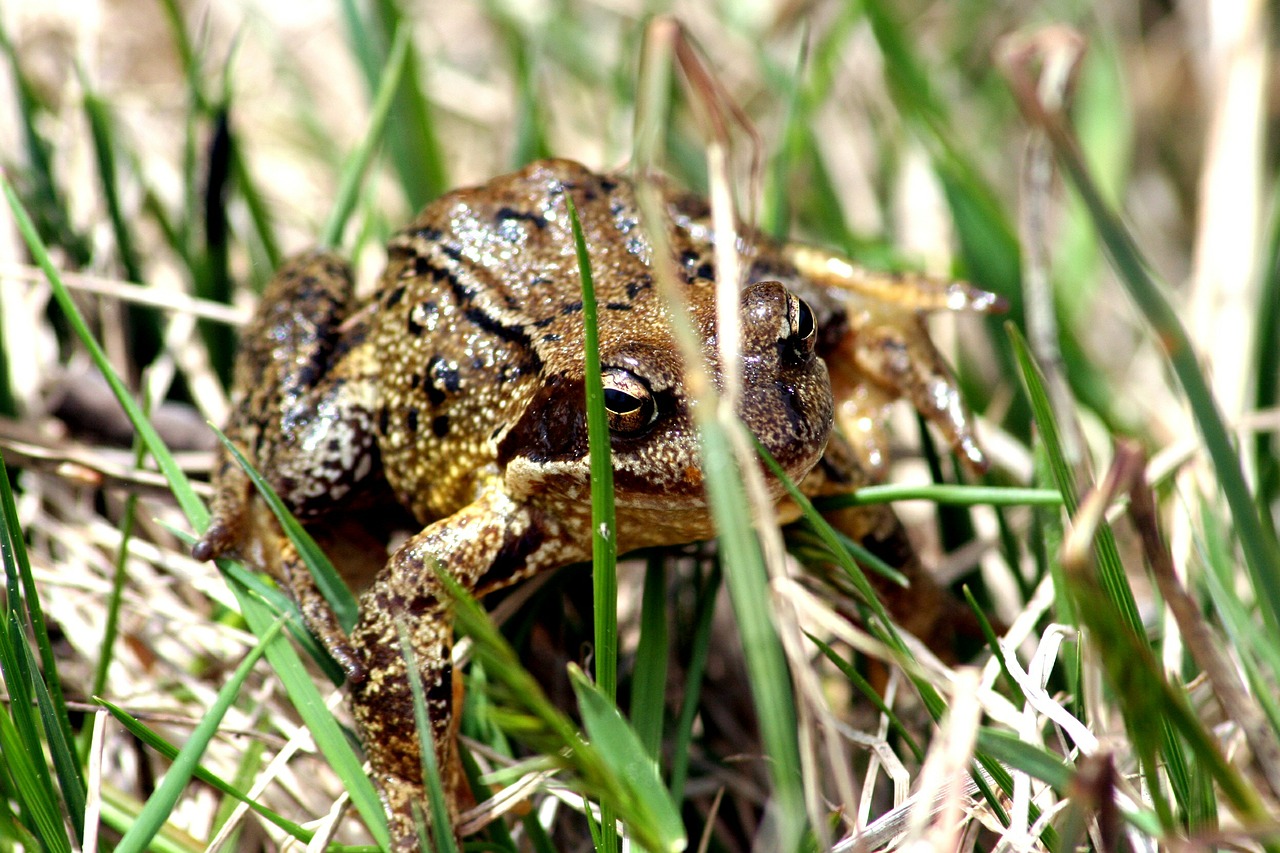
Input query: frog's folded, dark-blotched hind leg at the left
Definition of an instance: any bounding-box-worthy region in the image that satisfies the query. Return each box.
[192,252,376,678]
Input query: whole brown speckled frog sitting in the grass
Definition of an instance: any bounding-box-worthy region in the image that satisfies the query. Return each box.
[195,160,993,849]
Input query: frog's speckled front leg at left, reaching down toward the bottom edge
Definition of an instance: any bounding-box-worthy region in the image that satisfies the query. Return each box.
[351,475,590,850]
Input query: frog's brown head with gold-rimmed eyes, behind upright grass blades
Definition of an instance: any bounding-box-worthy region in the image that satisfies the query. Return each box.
[498,280,832,547]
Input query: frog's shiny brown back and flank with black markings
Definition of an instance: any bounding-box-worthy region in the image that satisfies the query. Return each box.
[370,160,668,520]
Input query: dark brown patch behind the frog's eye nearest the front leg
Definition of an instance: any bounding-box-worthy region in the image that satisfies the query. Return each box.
[498,374,586,465]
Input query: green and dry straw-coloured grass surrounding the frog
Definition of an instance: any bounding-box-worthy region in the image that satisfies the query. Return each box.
[0,0,1280,850]
